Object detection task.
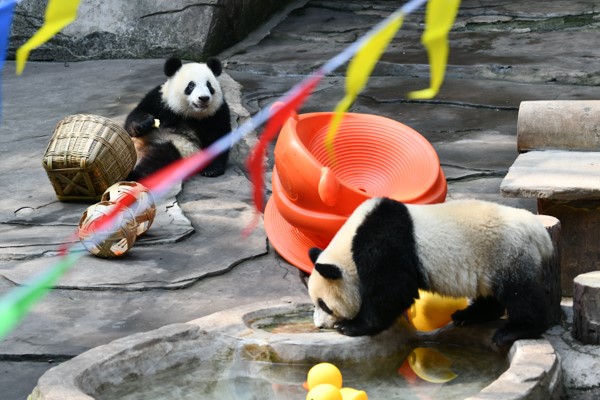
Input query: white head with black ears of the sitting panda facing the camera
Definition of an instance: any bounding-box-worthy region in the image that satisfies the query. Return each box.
[162,58,223,119]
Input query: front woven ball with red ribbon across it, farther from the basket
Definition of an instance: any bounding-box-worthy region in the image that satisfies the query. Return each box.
[77,201,137,258]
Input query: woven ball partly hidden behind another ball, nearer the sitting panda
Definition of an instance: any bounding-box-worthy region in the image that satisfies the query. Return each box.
[101,181,156,236]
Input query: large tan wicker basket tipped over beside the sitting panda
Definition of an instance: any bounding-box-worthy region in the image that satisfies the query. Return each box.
[43,114,136,201]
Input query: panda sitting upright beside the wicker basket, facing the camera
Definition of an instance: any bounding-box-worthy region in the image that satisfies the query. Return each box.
[125,58,231,180]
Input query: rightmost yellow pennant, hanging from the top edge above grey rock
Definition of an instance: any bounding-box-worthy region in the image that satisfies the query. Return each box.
[408,0,460,99]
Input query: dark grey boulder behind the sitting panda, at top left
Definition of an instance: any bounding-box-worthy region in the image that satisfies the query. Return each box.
[8,0,289,61]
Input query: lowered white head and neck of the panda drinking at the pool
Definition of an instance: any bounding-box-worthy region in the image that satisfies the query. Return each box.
[308,199,378,328]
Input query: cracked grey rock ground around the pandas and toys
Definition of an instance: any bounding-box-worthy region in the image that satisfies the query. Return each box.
[0,0,600,400]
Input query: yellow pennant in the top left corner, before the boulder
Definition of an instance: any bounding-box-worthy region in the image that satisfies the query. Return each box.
[16,0,80,75]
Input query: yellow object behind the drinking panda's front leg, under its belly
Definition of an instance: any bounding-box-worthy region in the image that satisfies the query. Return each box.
[407,290,468,331]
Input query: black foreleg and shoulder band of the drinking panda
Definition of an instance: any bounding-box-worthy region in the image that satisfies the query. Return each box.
[338,199,428,336]
